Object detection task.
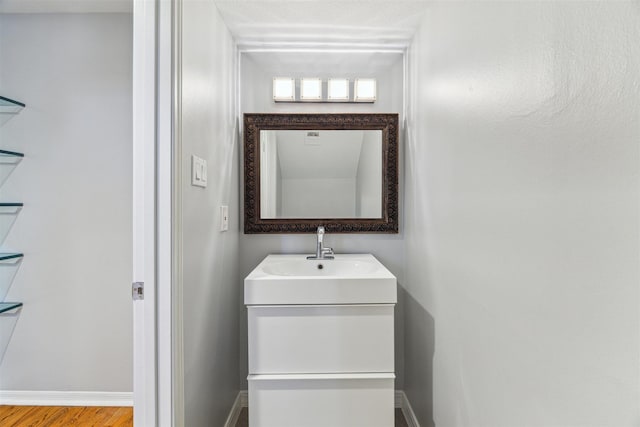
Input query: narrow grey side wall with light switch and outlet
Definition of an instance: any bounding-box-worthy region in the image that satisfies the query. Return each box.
[181,0,241,426]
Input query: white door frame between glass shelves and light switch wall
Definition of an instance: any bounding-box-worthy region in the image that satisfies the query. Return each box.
[133,0,176,427]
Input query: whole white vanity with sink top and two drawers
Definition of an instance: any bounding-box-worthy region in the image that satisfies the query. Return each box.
[244,254,397,427]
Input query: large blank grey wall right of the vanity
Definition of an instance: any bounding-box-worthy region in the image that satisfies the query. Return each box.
[405,2,640,427]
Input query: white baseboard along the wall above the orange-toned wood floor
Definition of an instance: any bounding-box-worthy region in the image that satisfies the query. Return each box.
[0,390,133,406]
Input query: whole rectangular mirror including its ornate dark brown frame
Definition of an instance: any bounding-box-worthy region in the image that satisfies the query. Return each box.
[244,113,398,233]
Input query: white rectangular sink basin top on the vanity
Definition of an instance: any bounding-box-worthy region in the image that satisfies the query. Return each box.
[244,254,397,305]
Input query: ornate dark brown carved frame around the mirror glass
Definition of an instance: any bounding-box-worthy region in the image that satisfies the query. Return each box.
[243,113,398,234]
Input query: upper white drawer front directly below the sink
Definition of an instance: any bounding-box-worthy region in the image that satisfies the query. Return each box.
[248,304,394,374]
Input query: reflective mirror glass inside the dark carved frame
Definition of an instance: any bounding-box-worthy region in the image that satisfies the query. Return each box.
[260,130,383,219]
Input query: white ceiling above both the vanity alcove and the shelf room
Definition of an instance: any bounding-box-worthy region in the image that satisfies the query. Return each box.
[0,0,428,48]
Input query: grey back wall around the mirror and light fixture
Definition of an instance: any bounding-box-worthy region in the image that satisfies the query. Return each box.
[238,52,405,388]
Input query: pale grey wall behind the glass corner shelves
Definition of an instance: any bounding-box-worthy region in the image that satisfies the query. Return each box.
[0,14,133,392]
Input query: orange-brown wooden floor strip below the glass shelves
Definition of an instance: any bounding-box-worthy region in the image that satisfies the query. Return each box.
[0,405,133,427]
